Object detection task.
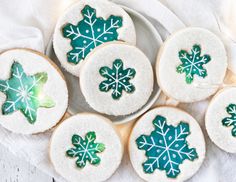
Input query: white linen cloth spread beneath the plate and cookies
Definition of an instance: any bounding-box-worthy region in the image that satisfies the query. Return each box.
[0,0,236,182]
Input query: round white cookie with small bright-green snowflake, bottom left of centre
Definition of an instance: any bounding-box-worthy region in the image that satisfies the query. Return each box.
[49,113,123,182]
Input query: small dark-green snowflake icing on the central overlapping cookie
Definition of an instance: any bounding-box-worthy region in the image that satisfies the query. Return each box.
[99,59,136,100]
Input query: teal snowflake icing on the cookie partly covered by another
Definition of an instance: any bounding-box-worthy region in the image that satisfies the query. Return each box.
[62,5,122,64]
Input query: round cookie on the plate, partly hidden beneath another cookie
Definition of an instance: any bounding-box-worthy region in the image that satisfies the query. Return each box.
[53,0,136,76]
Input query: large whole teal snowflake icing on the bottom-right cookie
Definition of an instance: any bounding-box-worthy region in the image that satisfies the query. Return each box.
[136,115,198,178]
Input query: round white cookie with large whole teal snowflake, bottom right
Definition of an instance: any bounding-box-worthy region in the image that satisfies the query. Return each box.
[129,107,205,182]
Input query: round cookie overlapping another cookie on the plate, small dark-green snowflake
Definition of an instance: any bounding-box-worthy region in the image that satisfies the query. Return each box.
[80,42,154,116]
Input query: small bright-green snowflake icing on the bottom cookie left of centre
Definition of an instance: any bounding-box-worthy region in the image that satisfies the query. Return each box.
[66,131,105,168]
